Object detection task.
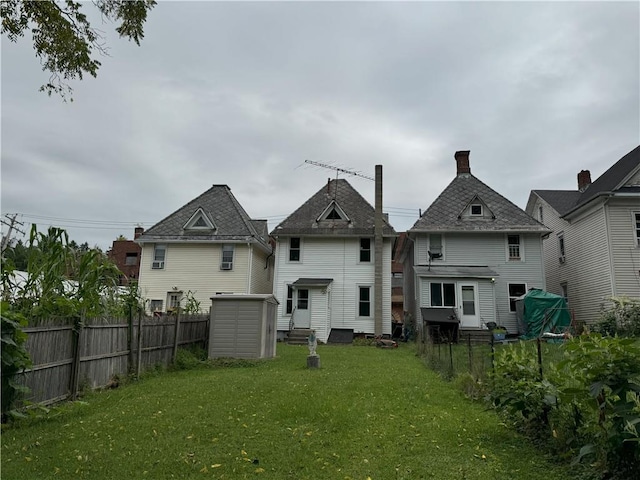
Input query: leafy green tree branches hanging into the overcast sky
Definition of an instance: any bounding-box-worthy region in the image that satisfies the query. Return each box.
[0,0,156,100]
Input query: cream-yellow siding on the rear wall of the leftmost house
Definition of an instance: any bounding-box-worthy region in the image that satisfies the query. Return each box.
[139,243,249,311]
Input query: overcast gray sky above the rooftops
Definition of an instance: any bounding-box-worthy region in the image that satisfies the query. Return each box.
[1,2,640,249]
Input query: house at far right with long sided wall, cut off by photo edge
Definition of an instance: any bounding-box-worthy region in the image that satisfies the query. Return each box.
[527,147,640,323]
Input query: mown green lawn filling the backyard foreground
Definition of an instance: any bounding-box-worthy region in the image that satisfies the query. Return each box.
[1,343,571,480]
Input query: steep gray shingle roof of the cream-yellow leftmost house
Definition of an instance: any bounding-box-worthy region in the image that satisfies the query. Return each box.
[136,185,271,250]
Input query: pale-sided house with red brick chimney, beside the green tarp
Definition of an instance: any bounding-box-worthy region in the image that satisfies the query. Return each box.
[402,151,549,333]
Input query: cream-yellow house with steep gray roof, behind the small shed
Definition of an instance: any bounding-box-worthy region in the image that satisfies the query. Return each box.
[136,185,273,312]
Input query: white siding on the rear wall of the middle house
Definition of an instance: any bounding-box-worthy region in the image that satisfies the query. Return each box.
[274,237,391,341]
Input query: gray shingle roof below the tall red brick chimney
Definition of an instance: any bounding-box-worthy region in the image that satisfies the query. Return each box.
[409,174,549,233]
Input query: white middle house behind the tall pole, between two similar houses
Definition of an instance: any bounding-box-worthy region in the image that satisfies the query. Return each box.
[271,179,396,342]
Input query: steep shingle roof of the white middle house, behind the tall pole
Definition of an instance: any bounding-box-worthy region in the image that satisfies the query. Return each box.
[271,178,396,236]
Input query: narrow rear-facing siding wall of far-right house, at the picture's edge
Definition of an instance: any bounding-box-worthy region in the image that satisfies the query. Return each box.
[606,197,640,298]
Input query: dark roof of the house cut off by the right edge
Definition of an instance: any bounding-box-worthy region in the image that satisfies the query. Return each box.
[530,146,640,216]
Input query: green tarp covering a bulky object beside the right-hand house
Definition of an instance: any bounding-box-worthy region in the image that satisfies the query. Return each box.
[516,288,571,339]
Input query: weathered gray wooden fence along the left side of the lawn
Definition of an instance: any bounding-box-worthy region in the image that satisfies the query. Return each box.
[21,315,209,405]
